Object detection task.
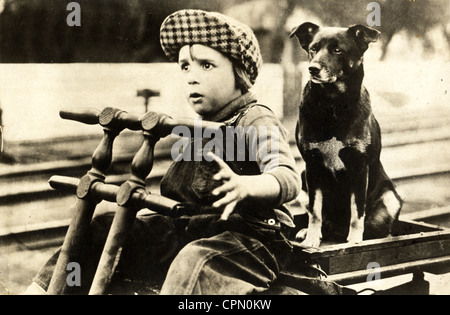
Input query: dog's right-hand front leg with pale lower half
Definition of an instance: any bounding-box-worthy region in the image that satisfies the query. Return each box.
[347,167,369,243]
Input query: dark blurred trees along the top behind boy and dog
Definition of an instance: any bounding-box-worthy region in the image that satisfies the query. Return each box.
[0,0,450,63]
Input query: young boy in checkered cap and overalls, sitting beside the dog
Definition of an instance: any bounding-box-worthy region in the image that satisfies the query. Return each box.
[26,10,300,294]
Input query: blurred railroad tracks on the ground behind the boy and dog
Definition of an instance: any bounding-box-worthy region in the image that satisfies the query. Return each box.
[0,112,450,247]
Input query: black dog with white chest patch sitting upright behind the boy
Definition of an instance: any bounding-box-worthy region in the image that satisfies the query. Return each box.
[291,23,402,247]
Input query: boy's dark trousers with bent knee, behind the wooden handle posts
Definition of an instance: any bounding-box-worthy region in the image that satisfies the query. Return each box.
[33,211,290,295]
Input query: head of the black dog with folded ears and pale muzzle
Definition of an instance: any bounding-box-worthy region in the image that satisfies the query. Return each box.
[290,22,380,84]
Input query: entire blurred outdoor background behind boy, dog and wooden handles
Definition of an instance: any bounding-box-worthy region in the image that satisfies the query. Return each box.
[0,0,450,294]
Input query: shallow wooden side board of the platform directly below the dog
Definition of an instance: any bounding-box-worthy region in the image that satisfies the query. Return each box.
[294,221,450,275]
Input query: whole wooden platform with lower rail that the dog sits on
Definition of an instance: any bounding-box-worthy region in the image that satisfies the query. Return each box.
[284,221,450,292]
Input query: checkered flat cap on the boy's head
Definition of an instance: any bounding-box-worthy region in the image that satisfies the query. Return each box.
[160,10,262,83]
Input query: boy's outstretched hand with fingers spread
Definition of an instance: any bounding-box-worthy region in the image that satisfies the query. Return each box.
[206,152,250,220]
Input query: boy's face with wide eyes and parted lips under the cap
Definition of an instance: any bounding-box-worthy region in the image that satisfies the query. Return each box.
[178,45,242,118]
